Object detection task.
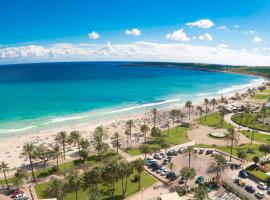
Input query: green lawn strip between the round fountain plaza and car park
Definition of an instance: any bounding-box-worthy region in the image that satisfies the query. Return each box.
[195,144,264,161]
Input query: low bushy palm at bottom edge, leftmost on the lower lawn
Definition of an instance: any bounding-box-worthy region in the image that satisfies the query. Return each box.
[46,177,66,200]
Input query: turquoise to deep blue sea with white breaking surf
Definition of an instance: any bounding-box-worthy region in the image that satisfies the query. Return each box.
[0,62,262,135]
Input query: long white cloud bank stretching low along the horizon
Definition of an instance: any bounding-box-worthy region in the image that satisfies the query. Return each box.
[0,42,270,66]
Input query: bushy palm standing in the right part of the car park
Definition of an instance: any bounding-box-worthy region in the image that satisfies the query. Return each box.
[208,154,227,180]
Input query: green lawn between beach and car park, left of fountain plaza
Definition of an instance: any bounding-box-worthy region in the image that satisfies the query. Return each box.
[126,127,190,156]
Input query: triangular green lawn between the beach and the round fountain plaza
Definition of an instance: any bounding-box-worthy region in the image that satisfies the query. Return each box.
[197,112,233,129]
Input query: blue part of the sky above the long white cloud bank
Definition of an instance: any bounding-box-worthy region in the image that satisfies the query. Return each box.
[0,0,270,63]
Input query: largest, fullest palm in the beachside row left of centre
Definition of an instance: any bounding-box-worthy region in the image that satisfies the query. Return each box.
[91,125,108,155]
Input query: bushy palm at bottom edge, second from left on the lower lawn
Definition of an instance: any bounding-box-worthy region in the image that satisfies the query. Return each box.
[66,173,82,200]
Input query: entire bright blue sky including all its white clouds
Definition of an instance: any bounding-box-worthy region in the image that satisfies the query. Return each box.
[0,0,270,66]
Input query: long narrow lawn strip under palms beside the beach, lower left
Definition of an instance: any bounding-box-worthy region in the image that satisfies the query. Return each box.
[0,150,117,185]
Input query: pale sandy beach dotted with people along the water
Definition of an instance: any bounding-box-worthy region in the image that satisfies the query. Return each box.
[0,73,268,168]
